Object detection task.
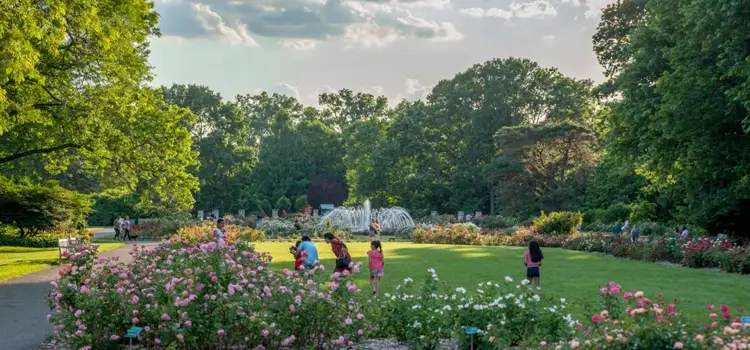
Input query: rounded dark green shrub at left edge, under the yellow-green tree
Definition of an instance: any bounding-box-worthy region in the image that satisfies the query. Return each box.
[0,177,93,237]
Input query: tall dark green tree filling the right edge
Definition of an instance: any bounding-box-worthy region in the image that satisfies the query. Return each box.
[597,0,750,232]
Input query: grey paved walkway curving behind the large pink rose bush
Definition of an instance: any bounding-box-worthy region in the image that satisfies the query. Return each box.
[0,228,157,350]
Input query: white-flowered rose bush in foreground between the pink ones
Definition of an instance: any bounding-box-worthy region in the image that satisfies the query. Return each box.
[374,269,577,349]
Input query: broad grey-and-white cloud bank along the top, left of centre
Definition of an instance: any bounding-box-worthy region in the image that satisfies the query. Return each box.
[156,0,463,50]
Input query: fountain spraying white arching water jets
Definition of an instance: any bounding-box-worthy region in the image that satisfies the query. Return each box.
[320,199,414,232]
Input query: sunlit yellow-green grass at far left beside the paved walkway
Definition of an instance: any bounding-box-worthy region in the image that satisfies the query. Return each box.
[0,243,122,281]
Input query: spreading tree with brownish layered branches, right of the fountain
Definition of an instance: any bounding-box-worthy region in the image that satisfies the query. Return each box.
[484,121,599,216]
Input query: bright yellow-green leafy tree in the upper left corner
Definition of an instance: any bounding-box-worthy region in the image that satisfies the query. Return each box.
[0,0,196,209]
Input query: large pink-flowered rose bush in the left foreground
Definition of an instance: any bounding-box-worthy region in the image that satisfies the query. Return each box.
[48,241,371,349]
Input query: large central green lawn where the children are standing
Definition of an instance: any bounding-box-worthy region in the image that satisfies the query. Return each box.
[256,242,750,319]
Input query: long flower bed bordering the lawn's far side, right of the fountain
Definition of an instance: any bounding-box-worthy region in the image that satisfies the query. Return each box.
[412,224,750,274]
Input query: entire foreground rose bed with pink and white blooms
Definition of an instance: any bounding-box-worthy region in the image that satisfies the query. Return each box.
[49,240,748,349]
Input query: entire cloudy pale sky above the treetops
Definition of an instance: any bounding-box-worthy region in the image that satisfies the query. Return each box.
[150,0,614,105]
